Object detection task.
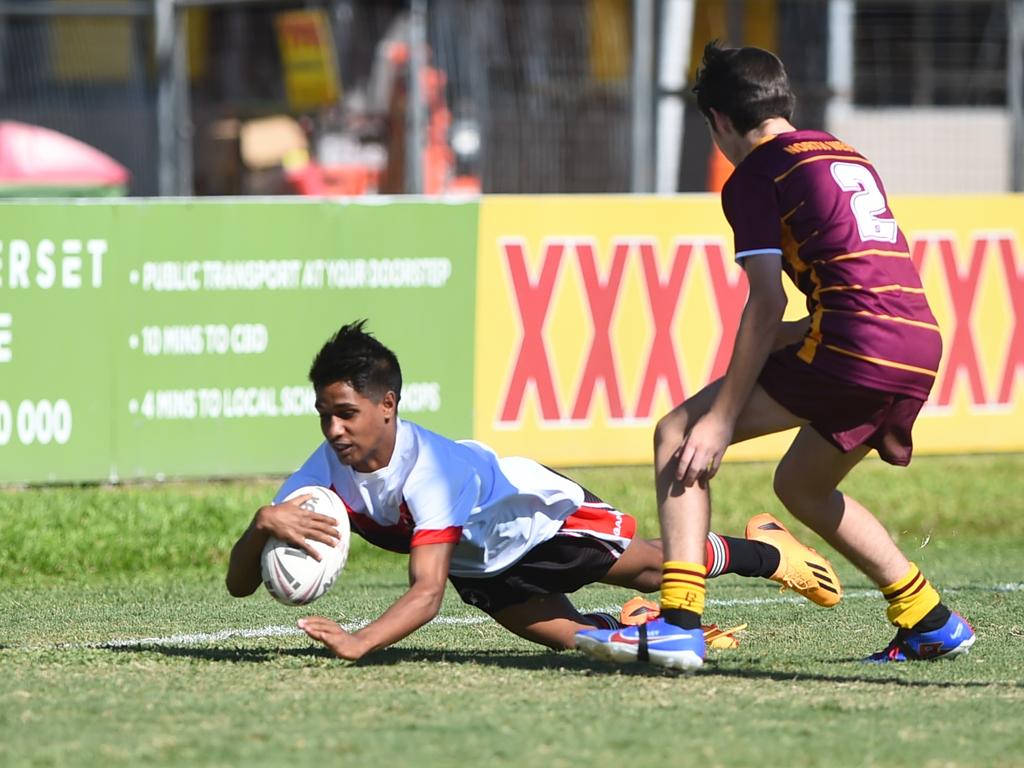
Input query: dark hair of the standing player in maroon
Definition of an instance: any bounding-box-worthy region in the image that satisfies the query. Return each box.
[693,40,797,134]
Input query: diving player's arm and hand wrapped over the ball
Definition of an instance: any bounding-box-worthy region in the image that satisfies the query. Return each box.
[224,496,338,597]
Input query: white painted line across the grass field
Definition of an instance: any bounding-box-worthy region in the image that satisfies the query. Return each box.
[11,583,1024,651]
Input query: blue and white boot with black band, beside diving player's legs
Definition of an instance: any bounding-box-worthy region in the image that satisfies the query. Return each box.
[575,618,705,671]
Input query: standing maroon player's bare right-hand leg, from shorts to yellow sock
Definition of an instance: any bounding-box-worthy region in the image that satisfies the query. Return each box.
[775,427,910,587]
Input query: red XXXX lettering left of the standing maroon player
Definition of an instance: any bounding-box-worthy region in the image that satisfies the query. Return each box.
[499,238,748,424]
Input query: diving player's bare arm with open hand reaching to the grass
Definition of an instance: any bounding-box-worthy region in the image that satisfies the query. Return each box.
[299,544,455,662]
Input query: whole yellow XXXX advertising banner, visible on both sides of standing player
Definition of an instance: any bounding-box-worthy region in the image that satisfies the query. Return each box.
[474,195,1024,465]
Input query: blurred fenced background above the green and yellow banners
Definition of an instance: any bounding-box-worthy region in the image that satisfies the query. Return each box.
[0,0,1024,197]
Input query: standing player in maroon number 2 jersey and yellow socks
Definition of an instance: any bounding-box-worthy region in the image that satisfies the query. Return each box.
[578,43,974,669]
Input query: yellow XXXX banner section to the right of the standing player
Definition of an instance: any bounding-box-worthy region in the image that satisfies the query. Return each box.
[893,196,1024,454]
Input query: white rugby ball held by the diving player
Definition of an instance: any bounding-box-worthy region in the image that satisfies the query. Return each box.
[260,485,351,605]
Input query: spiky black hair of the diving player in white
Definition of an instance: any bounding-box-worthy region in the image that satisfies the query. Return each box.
[309,319,401,402]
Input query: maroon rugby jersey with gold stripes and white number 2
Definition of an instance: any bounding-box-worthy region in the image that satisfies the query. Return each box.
[722,131,942,399]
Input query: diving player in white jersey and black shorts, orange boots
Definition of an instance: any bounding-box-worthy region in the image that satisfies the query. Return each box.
[226,321,841,660]
